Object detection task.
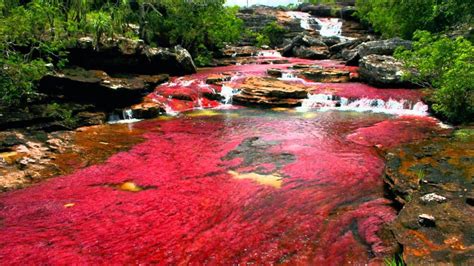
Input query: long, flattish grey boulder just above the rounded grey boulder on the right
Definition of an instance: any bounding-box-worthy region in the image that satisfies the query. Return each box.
[342,38,411,65]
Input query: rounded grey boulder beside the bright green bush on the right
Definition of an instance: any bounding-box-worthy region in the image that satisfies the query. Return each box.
[359,55,407,87]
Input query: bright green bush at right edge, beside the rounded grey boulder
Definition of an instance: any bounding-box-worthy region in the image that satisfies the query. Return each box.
[395,31,474,123]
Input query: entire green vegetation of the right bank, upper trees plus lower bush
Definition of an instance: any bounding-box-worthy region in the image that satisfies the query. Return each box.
[356,0,474,123]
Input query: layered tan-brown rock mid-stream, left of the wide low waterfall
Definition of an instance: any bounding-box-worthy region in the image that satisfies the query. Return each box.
[233,77,308,106]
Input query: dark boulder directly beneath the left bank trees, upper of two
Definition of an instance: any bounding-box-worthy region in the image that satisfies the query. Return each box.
[69,37,196,75]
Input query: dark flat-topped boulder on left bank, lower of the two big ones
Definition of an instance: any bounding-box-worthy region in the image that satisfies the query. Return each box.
[39,68,168,109]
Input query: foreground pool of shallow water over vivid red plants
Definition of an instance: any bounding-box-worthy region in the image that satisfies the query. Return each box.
[0,108,444,265]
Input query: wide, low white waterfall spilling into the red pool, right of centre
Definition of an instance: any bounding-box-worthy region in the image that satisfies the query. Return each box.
[298,94,428,116]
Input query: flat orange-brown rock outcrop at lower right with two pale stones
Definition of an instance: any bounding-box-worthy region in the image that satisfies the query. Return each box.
[385,128,474,265]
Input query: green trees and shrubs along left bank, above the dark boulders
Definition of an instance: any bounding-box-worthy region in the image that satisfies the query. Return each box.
[0,0,242,106]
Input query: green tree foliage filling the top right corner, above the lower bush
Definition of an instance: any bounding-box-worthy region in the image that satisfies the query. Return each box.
[356,0,474,39]
